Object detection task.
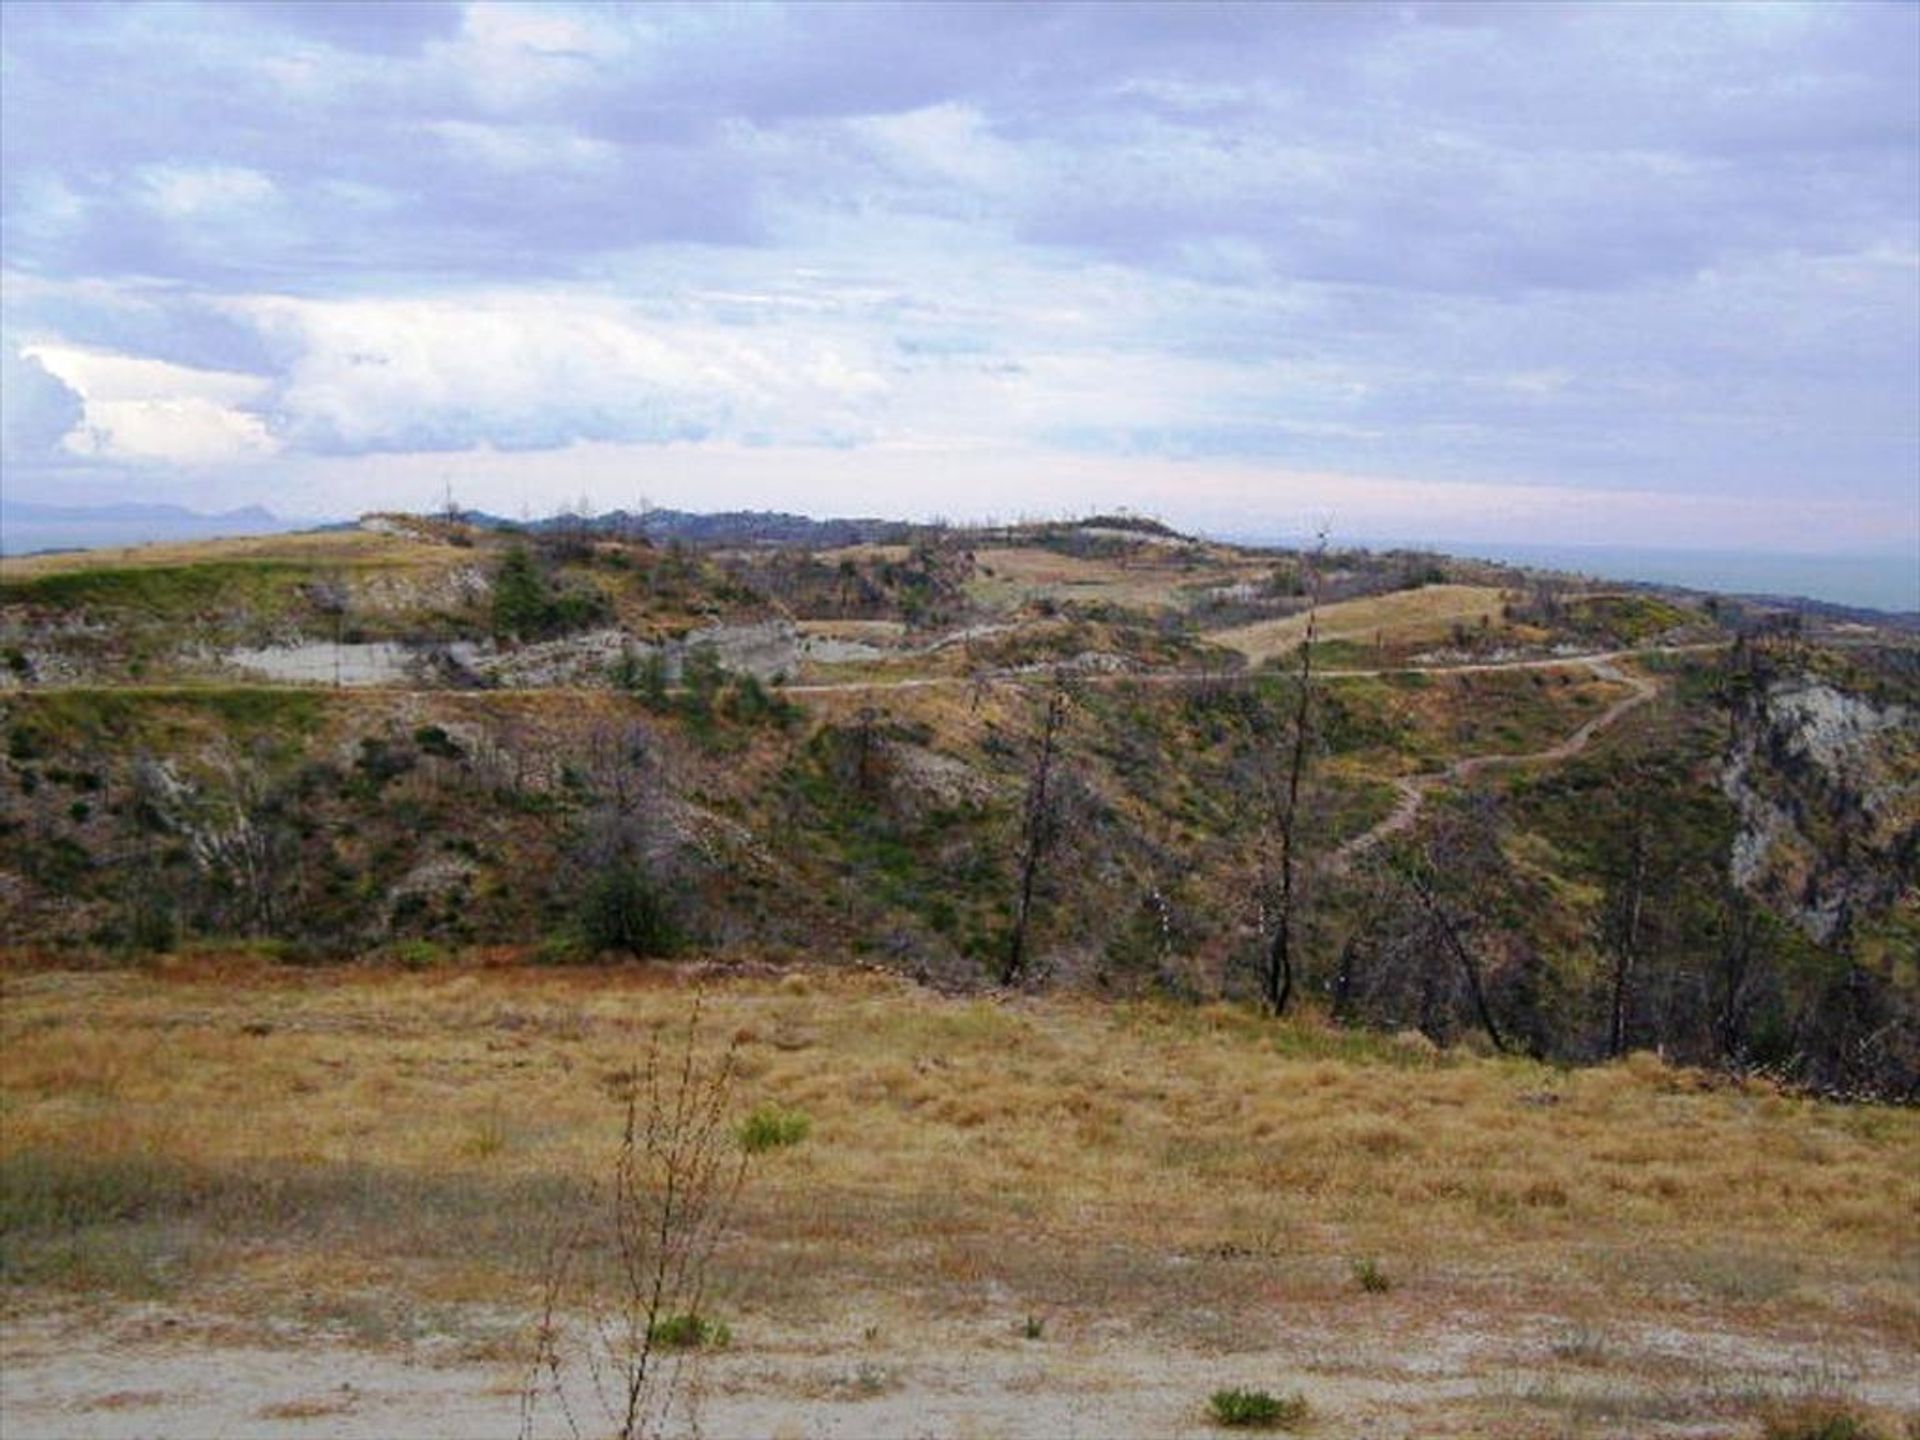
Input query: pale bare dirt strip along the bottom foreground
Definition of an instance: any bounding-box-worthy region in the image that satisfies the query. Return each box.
[0,1298,1920,1440]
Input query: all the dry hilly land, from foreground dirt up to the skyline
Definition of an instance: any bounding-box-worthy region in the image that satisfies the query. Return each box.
[0,516,1920,1440]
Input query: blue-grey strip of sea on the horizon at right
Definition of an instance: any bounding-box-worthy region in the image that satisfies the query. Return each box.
[1286,540,1920,611]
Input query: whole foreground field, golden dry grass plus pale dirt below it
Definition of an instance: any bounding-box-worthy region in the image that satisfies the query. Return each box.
[0,958,1920,1436]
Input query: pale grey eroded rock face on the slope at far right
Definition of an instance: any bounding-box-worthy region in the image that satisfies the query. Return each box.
[1720,676,1920,945]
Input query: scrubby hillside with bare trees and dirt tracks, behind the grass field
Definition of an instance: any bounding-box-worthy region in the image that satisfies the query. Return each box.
[0,516,1920,1094]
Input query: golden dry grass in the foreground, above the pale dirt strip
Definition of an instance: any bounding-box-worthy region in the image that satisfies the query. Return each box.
[0,962,1920,1434]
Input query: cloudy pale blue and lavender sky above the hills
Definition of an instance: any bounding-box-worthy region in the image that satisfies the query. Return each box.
[0,0,1920,553]
